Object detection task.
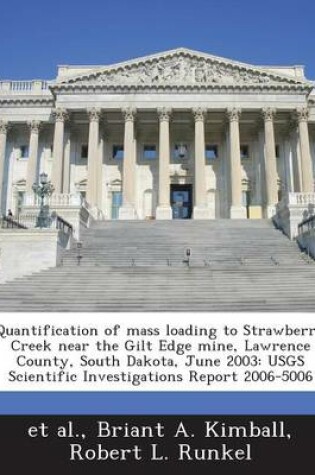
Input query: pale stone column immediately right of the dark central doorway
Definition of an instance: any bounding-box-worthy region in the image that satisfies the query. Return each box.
[193,107,215,219]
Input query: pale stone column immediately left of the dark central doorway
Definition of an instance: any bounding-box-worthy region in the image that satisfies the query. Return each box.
[156,107,172,219]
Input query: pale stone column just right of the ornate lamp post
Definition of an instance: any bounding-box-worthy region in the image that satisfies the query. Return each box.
[51,108,68,193]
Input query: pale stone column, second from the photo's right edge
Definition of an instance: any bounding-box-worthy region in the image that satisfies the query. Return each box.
[262,107,278,218]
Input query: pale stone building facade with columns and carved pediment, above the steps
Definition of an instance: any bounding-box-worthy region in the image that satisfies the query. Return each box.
[0,48,315,219]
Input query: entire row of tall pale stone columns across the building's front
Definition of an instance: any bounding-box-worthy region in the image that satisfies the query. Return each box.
[0,107,313,219]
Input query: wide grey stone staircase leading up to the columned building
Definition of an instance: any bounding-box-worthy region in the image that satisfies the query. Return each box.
[0,220,315,312]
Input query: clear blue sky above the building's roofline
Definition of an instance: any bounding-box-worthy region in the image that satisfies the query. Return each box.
[0,0,315,80]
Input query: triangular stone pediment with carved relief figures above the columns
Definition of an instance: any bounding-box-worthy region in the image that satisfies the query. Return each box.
[52,48,313,92]
